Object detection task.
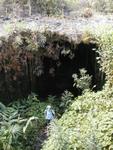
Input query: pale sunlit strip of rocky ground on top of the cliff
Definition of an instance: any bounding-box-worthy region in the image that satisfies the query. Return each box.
[0,15,113,42]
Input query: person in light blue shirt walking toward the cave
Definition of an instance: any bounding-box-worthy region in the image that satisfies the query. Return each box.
[44,105,55,125]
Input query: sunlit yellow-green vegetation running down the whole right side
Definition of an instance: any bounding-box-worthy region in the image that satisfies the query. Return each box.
[42,26,113,150]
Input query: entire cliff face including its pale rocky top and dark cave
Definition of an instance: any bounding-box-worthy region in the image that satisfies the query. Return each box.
[0,14,112,102]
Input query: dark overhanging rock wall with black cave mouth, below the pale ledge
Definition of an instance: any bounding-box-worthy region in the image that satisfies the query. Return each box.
[0,30,104,99]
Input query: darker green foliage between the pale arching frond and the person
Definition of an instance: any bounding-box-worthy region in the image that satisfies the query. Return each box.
[11,93,47,150]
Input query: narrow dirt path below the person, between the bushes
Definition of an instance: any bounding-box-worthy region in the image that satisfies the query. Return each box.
[35,127,48,150]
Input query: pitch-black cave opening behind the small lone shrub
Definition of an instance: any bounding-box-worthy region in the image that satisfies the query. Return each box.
[35,43,102,97]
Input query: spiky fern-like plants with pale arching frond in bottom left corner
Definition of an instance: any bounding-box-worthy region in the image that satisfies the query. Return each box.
[0,103,37,150]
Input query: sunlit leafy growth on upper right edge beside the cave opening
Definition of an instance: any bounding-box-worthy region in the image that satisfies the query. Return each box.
[91,25,113,86]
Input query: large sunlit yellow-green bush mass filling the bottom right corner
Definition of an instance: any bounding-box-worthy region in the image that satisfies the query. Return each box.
[43,88,113,150]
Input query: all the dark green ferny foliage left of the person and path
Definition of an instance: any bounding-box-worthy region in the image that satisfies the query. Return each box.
[0,94,47,150]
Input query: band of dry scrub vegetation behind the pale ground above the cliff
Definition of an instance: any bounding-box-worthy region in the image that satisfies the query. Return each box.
[0,0,113,17]
